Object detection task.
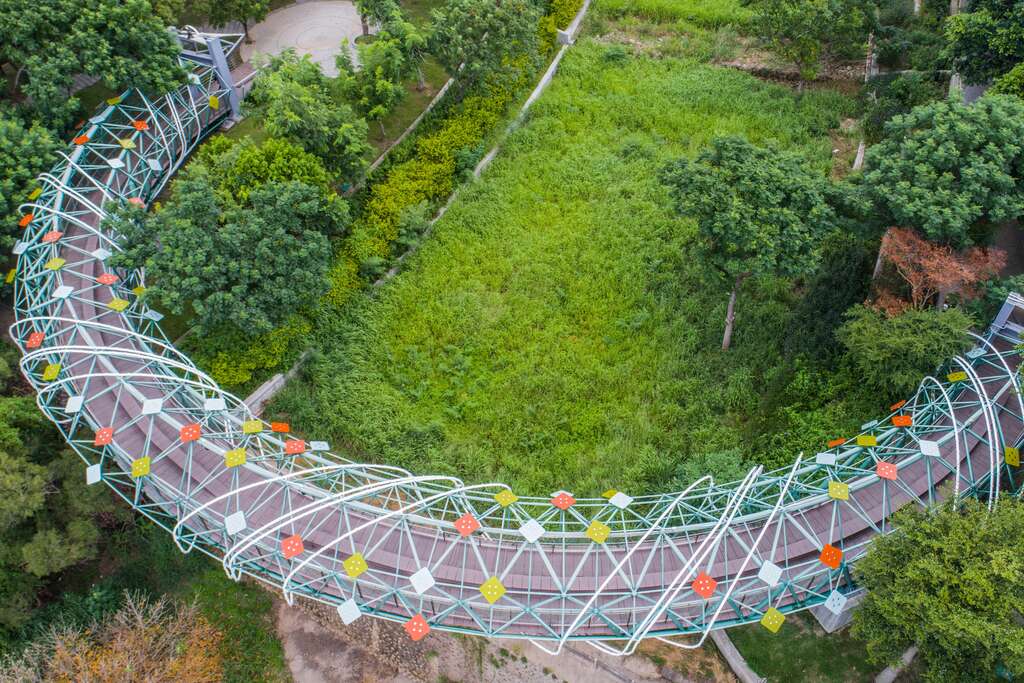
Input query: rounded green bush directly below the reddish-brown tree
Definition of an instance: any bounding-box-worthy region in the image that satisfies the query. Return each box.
[837,306,973,396]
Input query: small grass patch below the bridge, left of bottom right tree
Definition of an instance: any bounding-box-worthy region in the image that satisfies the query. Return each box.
[729,611,882,683]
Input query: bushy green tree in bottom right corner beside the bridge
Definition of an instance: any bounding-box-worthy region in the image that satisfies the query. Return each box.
[853,497,1024,683]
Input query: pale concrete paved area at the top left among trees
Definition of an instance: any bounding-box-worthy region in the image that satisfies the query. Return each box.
[242,0,362,77]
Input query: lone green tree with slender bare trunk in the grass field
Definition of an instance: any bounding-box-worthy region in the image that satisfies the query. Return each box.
[663,137,837,350]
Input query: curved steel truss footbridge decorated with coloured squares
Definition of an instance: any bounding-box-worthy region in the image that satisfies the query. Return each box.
[9,36,1024,653]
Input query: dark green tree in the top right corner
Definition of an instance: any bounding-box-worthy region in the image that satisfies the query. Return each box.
[945,0,1024,84]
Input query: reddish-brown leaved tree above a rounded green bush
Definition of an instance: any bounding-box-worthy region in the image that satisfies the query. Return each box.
[874,227,1007,314]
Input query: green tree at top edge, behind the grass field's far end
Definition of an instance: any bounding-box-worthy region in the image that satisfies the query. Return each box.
[754,0,868,89]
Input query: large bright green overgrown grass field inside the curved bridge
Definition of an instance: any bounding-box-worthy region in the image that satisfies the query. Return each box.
[267,31,863,495]
